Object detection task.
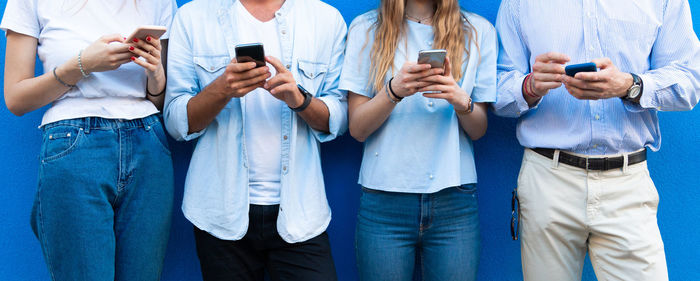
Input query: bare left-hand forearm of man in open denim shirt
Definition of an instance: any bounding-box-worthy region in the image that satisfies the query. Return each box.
[187,81,231,134]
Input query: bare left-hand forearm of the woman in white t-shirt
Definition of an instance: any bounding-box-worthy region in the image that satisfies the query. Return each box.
[5,57,82,116]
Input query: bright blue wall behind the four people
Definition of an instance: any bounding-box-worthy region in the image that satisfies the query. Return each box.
[0,0,700,281]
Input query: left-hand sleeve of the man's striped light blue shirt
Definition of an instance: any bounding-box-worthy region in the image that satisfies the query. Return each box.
[493,0,536,117]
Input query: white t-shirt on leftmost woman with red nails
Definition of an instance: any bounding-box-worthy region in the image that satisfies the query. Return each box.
[0,0,177,126]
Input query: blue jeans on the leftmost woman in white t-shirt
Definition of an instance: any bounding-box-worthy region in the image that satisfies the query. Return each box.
[31,115,174,281]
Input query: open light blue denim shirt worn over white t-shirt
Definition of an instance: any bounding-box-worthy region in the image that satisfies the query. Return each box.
[164,0,347,243]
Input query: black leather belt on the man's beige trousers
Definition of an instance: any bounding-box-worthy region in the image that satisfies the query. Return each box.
[532,148,647,171]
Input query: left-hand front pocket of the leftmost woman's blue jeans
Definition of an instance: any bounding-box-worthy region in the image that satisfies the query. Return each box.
[40,125,85,163]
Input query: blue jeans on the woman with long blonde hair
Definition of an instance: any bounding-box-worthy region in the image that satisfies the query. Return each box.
[355,184,480,281]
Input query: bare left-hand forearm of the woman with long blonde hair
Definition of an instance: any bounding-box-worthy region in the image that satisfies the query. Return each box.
[349,86,396,142]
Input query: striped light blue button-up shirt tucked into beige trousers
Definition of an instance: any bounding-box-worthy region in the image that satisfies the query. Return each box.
[494,0,700,155]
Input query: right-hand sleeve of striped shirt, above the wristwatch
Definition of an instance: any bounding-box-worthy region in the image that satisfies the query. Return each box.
[625,0,700,111]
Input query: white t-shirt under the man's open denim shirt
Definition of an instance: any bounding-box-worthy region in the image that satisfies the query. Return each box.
[235,1,286,205]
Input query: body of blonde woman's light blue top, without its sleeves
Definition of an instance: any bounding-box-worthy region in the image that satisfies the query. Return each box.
[351,12,495,193]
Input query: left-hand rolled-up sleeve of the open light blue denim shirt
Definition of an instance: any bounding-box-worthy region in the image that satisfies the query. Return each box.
[163,10,206,141]
